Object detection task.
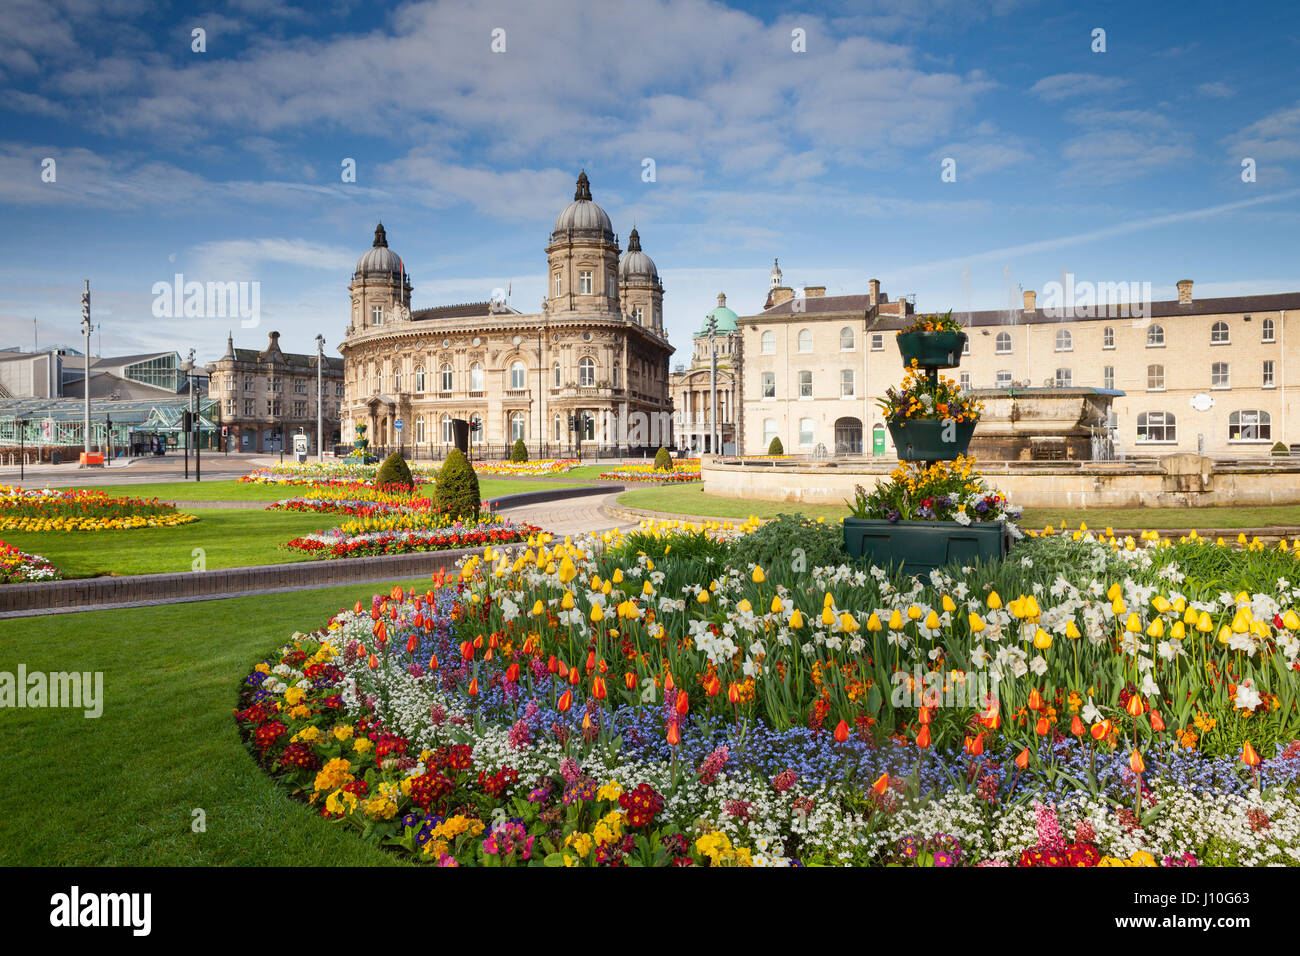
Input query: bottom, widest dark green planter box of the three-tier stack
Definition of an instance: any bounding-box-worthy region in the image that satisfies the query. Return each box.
[844,518,1010,575]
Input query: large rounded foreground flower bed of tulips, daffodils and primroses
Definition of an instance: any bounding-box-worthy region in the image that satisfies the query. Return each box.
[238,519,1300,866]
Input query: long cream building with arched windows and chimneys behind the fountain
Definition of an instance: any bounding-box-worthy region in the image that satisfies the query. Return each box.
[740,280,1300,458]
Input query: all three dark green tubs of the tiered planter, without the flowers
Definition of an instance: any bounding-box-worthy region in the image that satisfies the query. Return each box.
[844,332,1011,575]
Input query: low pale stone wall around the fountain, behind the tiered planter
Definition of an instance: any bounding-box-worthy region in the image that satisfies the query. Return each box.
[701,454,1300,509]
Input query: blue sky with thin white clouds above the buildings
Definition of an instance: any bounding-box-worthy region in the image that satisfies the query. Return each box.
[0,0,1300,360]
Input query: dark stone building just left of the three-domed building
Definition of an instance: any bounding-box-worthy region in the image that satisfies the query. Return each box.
[207,332,343,454]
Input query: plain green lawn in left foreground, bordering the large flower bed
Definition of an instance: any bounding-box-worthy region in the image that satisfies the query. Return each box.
[0,579,428,866]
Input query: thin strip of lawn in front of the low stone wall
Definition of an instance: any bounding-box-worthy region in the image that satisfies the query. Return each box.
[619,485,1300,532]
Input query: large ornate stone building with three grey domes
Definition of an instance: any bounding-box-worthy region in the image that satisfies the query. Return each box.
[339,172,672,458]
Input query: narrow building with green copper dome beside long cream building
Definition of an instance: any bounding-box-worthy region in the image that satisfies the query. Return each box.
[671,293,744,454]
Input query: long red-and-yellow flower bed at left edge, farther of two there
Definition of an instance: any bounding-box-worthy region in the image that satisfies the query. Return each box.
[0,485,199,531]
